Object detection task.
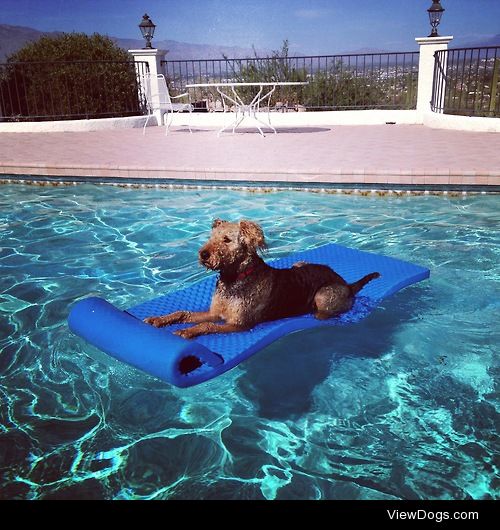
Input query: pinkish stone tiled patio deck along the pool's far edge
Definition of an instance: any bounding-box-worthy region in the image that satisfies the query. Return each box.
[0,125,500,186]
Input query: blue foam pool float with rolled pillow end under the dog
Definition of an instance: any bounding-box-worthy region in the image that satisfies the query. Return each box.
[68,244,429,387]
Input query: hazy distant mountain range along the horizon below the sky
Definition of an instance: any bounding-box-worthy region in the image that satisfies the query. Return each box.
[0,24,500,62]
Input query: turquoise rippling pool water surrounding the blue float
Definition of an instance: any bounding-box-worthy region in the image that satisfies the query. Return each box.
[0,185,500,499]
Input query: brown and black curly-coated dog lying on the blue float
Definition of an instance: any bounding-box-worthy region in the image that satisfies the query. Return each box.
[144,219,380,339]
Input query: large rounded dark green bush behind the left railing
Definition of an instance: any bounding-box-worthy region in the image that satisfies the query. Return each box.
[0,33,145,120]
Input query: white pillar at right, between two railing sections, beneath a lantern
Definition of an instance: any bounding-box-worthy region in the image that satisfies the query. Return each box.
[415,36,453,114]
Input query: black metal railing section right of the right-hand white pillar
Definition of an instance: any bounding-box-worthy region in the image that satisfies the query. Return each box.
[431,46,500,118]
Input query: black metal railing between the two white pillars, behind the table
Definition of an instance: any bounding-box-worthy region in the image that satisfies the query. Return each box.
[162,52,419,110]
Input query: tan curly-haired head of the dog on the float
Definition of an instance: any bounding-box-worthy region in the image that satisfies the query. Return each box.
[199,219,266,270]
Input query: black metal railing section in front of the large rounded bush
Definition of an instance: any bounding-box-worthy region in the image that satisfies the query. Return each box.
[0,61,148,121]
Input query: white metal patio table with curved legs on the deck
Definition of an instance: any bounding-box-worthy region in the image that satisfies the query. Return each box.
[186,81,308,136]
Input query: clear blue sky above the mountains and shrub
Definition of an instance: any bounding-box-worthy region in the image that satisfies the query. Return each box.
[0,0,500,54]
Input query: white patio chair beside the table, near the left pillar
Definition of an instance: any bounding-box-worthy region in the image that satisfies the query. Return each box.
[141,74,194,135]
